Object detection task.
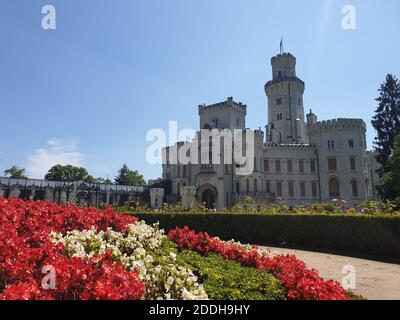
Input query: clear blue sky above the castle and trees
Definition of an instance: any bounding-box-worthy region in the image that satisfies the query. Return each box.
[0,0,400,179]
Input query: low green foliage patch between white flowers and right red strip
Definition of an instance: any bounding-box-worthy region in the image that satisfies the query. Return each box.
[177,250,286,300]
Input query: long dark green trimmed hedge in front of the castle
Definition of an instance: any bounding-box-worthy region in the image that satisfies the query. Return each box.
[134,213,400,258]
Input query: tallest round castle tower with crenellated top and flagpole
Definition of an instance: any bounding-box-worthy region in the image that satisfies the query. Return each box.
[265,47,308,144]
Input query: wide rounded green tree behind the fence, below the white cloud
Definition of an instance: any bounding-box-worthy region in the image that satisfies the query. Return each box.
[44,164,94,183]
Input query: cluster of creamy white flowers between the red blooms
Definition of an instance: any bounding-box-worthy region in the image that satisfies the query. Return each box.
[51,221,207,300]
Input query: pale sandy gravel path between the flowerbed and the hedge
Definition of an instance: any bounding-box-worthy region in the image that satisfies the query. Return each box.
[260,247,400,300]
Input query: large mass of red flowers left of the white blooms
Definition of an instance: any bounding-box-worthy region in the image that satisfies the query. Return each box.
[0,198,144,300]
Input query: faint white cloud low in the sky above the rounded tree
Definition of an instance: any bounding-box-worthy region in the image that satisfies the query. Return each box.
[26,139,85,179]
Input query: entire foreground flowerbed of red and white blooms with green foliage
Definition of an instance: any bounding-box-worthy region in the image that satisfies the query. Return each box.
[0,198,346,300]
